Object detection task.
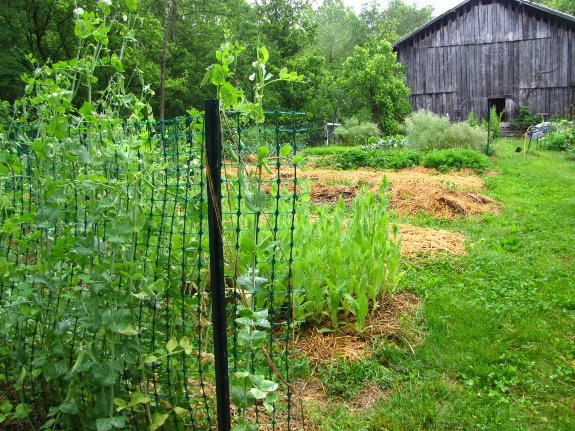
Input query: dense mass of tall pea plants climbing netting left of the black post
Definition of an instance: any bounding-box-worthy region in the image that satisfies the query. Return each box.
[0,0,218,431]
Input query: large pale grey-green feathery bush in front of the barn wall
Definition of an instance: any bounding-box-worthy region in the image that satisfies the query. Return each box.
[405,110,487,151]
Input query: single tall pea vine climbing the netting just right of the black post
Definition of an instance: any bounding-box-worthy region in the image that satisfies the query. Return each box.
[203,32,303,431]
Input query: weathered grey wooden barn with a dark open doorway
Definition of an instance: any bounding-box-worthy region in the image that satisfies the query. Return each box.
[393,0,575,120]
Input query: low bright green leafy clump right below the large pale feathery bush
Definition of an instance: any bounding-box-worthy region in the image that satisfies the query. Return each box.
[422,149,491,173]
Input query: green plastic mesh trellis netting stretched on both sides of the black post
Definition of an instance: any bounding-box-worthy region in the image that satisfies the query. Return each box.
[0,104,305,430]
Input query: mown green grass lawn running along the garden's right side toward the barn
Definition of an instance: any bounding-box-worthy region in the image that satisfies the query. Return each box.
[316,140,575,431]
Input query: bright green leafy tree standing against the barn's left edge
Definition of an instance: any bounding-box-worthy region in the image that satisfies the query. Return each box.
[339,40,411,135]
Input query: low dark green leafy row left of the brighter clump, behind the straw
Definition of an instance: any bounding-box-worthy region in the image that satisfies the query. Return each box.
[335,149,421,170]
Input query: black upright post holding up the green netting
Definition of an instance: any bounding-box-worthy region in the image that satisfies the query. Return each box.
[204,100,231,431]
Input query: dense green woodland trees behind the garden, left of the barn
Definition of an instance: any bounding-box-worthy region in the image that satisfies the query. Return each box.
[0,0,575,133]
